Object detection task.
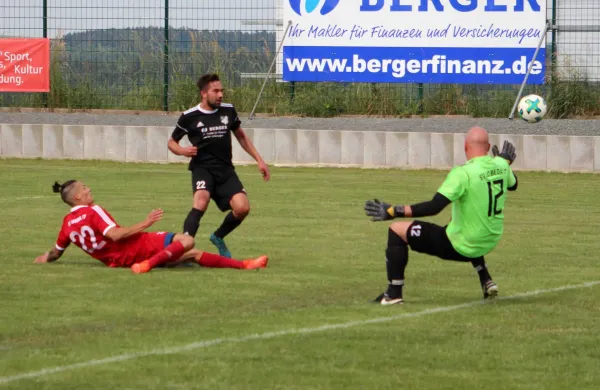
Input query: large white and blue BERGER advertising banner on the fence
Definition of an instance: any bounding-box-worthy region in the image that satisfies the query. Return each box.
[282,0,546,84]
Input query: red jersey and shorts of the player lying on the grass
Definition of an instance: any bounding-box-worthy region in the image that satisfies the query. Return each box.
[56,205,165,267]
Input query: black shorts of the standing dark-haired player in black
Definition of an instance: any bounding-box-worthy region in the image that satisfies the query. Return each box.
[192,168,246,211]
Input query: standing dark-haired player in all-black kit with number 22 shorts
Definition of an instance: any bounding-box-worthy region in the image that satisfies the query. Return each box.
[168,74,271,257]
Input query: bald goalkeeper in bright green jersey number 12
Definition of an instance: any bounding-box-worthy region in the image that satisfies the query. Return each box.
[365,127,517,305]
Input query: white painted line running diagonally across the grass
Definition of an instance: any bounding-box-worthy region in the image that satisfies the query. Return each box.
[0,280,600,384]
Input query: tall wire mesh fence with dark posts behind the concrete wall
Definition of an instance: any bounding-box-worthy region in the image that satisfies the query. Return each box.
[0,0,600,118]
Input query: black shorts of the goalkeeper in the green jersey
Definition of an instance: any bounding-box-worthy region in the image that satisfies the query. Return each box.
[406,221,481,261]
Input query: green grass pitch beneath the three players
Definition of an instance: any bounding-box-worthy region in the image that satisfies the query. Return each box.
[0,160,600,389]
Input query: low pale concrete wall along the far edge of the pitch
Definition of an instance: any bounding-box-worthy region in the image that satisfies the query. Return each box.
[0,124,600,172]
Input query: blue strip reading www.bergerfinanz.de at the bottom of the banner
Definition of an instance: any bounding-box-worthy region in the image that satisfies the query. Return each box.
[283,46,546,84]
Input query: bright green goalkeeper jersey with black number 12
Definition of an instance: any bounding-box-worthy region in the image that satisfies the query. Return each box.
[438,156,517,258]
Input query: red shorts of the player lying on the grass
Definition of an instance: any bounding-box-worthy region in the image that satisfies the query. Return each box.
[101,232,175,267]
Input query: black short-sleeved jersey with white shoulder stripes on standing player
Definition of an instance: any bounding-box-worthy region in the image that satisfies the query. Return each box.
[171,103,242,170]
